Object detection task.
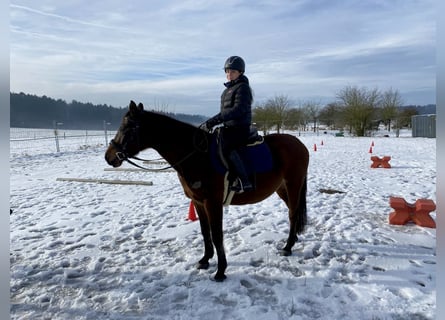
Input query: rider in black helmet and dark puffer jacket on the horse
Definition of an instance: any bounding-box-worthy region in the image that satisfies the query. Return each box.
[205,56,253,193]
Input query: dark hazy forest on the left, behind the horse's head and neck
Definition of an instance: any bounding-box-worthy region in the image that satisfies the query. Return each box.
[10,92,206,130]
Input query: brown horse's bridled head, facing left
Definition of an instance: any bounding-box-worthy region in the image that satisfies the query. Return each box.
[105,101,144,167]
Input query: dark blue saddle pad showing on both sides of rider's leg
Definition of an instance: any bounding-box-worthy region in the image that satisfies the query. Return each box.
[210,135,273,175]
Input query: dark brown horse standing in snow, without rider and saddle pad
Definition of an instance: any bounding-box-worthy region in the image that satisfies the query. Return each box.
[105,101,309,281]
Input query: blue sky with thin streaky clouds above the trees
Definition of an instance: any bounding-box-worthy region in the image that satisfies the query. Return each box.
[10,0,436,116]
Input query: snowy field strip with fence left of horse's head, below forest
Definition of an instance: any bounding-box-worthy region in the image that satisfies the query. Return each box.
[9,128,116,156]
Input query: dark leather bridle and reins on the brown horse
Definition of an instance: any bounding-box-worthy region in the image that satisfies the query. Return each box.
[110,120,208,171]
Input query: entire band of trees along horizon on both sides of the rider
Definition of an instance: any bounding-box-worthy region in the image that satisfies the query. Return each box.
[10,86,435,136]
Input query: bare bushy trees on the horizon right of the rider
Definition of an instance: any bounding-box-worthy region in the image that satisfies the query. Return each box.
[253,86,435,136]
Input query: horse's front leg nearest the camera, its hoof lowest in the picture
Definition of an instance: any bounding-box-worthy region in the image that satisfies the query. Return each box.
[205,201,227,282]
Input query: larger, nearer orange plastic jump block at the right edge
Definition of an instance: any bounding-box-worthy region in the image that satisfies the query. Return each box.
[389,197,436,228]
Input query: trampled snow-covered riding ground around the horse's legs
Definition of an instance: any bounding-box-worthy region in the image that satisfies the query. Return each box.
[10,134,436,320]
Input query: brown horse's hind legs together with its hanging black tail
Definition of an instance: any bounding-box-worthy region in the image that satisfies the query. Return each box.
[277,179,307,256]
